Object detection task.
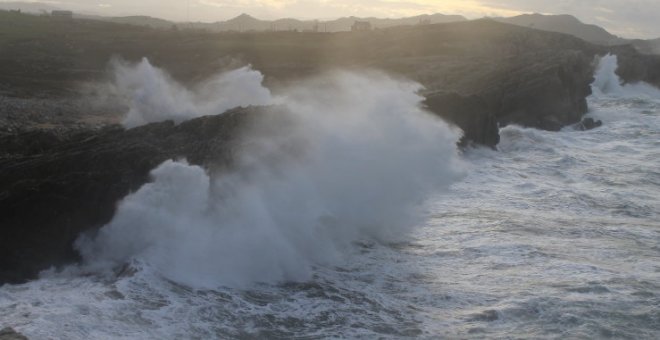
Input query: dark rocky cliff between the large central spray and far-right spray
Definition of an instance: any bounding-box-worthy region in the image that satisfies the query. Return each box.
[426,51,594,147]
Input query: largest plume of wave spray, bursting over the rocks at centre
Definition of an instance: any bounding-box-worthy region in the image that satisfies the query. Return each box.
[77,65,461,288]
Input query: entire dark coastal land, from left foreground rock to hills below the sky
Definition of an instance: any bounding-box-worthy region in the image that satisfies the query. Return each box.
[0,11,660,284]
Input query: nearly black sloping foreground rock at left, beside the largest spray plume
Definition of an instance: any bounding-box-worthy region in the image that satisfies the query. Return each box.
[0,108,262,284]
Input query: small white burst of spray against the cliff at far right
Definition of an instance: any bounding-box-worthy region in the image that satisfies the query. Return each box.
[591,54,660,100]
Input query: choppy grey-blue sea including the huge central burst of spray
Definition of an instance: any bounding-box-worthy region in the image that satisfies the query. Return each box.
[0,56,660,339]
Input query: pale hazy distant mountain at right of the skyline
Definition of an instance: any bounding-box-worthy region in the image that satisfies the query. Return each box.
[494,14,628,45]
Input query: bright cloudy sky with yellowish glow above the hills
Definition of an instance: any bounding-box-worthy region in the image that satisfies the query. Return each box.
[2,0,660,38]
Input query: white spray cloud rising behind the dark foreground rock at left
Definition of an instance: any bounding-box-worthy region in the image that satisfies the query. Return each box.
[112,58,271,128]
